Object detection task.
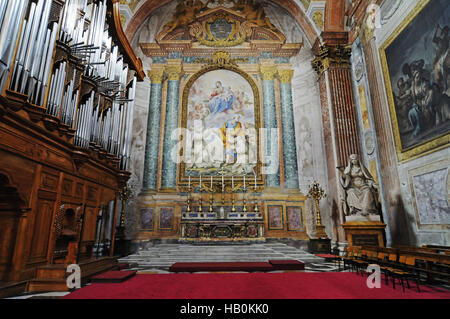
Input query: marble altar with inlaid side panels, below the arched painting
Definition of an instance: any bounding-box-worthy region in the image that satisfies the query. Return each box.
[136,188,309,242]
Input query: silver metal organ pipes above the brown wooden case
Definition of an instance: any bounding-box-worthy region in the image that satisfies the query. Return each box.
[0,0,137,170]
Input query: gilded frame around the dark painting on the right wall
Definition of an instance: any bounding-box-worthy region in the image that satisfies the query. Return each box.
[379,0,450,162]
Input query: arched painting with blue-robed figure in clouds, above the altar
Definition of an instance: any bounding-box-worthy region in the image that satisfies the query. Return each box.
[185,69,257,176]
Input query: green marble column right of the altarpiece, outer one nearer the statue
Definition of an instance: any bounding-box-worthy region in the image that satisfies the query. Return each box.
[278,69,299,189]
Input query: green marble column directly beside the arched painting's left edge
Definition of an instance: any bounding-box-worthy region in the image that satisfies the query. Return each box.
[161,65,182,190]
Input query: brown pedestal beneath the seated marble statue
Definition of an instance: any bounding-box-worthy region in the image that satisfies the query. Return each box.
[343,221,386,247]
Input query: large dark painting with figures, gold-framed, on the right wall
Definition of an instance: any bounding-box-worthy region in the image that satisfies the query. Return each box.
[381,0,450,158]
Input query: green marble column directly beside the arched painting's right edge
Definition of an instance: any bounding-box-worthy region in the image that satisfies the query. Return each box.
[260,65,280,187]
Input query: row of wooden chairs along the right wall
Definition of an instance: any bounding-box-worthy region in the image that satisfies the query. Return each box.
[341,246,450,291]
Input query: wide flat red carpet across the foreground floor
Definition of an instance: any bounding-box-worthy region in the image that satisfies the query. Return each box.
[64,273,450,299]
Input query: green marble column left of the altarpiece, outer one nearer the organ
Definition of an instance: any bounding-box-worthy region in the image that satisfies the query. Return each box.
[143,69,164,190]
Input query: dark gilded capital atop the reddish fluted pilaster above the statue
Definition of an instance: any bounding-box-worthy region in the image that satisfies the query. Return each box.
[312,45,352,75]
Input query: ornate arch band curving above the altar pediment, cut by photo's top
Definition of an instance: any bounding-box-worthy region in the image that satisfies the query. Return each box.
[125,0,320,46]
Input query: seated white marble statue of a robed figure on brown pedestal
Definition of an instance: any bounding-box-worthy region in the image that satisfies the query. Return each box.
[340,154,379,216]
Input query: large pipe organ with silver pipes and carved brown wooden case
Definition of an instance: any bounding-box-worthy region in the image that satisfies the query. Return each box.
[0,0,145,296]
